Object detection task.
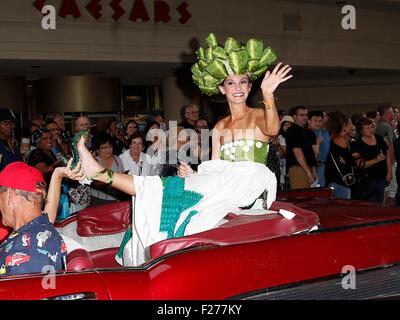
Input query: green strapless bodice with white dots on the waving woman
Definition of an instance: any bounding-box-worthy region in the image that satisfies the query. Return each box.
[220,139,269,164]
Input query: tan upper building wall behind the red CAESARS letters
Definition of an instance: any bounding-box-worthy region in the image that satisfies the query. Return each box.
[0,0,400,69]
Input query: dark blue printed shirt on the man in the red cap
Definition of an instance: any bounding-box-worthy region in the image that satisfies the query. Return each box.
[0,214,67,276]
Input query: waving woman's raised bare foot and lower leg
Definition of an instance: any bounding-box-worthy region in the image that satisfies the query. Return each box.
[78,137,135,196]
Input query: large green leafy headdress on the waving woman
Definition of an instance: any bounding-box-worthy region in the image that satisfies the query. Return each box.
[191,33,277,95]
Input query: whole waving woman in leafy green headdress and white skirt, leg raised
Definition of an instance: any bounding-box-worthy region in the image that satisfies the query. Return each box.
[64,34,292,266]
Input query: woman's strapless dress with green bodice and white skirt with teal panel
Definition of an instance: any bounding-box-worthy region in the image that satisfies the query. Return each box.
[116,139,277,266]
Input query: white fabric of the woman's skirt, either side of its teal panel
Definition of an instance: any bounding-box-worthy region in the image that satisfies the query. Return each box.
[116,160,277,266]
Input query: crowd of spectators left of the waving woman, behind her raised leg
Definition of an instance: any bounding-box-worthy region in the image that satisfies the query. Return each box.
[0,104,211,218]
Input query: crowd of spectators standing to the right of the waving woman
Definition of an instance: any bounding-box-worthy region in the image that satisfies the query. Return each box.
[273,105,400,205]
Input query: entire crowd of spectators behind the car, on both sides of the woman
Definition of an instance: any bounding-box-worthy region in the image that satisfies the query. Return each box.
[0,104,400,222]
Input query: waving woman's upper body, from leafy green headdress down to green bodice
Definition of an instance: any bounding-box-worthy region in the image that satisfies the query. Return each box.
[179,34,292,177]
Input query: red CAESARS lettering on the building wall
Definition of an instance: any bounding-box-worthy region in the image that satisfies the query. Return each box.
[33,0,192,24]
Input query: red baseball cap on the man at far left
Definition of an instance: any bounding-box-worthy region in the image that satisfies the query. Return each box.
[0,161,46,192]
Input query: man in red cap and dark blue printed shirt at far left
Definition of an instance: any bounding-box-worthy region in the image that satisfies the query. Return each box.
[0,161,66,276]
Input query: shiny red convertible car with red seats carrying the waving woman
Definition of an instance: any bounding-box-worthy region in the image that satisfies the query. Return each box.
[0,189,400,300]
